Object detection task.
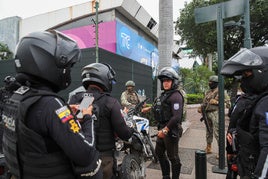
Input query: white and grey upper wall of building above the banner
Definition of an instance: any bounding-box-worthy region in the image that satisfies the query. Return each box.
[0,0,158,59]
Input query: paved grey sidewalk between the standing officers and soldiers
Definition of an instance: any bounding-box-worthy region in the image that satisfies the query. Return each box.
[146,105,228,179]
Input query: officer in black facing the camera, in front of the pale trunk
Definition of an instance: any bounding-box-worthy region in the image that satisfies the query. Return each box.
[142,67,184,179]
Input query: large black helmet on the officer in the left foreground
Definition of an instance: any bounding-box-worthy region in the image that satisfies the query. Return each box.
[15,30,81,91]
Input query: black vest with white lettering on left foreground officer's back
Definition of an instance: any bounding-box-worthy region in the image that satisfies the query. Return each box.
[3,86,74,179]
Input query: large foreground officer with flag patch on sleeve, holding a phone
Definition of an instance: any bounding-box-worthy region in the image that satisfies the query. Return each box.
[2,30,102,179]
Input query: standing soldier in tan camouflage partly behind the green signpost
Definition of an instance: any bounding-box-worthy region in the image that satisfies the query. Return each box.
[198,75,230,154]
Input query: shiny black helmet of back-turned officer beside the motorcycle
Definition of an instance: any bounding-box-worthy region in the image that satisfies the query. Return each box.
[82,63,116,93]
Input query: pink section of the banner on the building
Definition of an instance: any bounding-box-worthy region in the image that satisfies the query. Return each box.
[62,21,116,53]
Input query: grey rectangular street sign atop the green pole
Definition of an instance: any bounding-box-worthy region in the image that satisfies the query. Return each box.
[194,0,246,24]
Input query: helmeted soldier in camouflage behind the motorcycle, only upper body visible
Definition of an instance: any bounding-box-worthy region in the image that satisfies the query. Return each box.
[121,80,140,109]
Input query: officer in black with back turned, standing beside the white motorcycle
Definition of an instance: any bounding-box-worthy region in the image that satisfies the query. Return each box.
[69,63,133,179]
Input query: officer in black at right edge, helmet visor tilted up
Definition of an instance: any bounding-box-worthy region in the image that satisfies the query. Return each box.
[221,47,268,179]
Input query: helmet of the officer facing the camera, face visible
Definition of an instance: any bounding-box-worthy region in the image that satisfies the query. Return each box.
[158,67,179,90]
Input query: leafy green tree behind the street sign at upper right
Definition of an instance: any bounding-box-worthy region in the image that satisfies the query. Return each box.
[175,0,268,59]
